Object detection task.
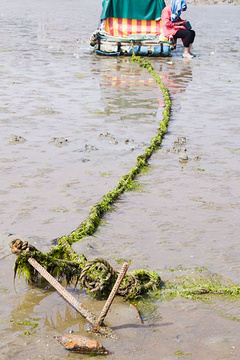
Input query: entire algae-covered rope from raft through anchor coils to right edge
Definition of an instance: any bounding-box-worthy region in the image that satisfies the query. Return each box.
[10,55,240,299]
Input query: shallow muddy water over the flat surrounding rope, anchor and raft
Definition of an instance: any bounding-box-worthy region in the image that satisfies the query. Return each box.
[0,0,240,360]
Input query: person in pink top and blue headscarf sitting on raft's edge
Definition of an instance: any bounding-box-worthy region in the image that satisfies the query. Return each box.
[161,0,195,58]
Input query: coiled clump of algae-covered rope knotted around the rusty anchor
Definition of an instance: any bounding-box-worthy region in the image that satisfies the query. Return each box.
[10,239,161,299]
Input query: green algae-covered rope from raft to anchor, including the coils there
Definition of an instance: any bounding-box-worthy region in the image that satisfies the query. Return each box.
[10,55,171,298]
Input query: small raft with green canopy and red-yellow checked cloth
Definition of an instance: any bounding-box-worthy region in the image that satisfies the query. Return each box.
[90,0,175,56]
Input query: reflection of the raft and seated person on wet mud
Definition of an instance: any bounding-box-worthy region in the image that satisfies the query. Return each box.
[92,55,192,121]
